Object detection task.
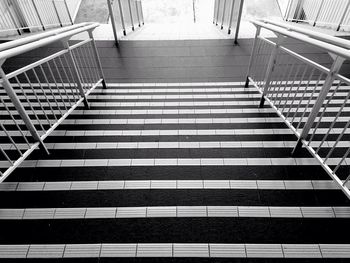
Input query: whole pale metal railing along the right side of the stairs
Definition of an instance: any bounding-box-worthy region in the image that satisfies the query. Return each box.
[246,21,350,198]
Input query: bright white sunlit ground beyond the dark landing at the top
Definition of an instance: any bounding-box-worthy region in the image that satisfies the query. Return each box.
[72,0,288,40]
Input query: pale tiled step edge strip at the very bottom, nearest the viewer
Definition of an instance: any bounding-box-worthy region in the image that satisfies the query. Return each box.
[0,243,350,259]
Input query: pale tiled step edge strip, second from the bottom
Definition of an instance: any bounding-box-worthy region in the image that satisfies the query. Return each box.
[0,206,350,220]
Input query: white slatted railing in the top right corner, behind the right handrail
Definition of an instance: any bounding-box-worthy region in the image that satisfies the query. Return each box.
[285,0,350,31]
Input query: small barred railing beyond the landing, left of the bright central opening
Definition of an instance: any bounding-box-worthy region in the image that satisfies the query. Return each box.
[107,0,145,44]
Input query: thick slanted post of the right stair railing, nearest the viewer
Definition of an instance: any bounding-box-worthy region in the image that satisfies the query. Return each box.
[292,56,345,155]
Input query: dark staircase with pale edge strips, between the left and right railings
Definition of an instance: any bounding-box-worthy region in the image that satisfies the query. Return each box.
[0,82,350,262]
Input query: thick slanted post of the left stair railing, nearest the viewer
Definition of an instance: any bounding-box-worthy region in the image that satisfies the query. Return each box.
[0,64,50,154]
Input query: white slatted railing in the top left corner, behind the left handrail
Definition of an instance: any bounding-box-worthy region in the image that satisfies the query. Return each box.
[0,0,73,37]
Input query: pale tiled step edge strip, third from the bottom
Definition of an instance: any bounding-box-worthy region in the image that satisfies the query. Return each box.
[0,180,344,192]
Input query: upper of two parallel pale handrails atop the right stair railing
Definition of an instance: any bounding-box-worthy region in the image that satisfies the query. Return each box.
[261,19,350,49]
